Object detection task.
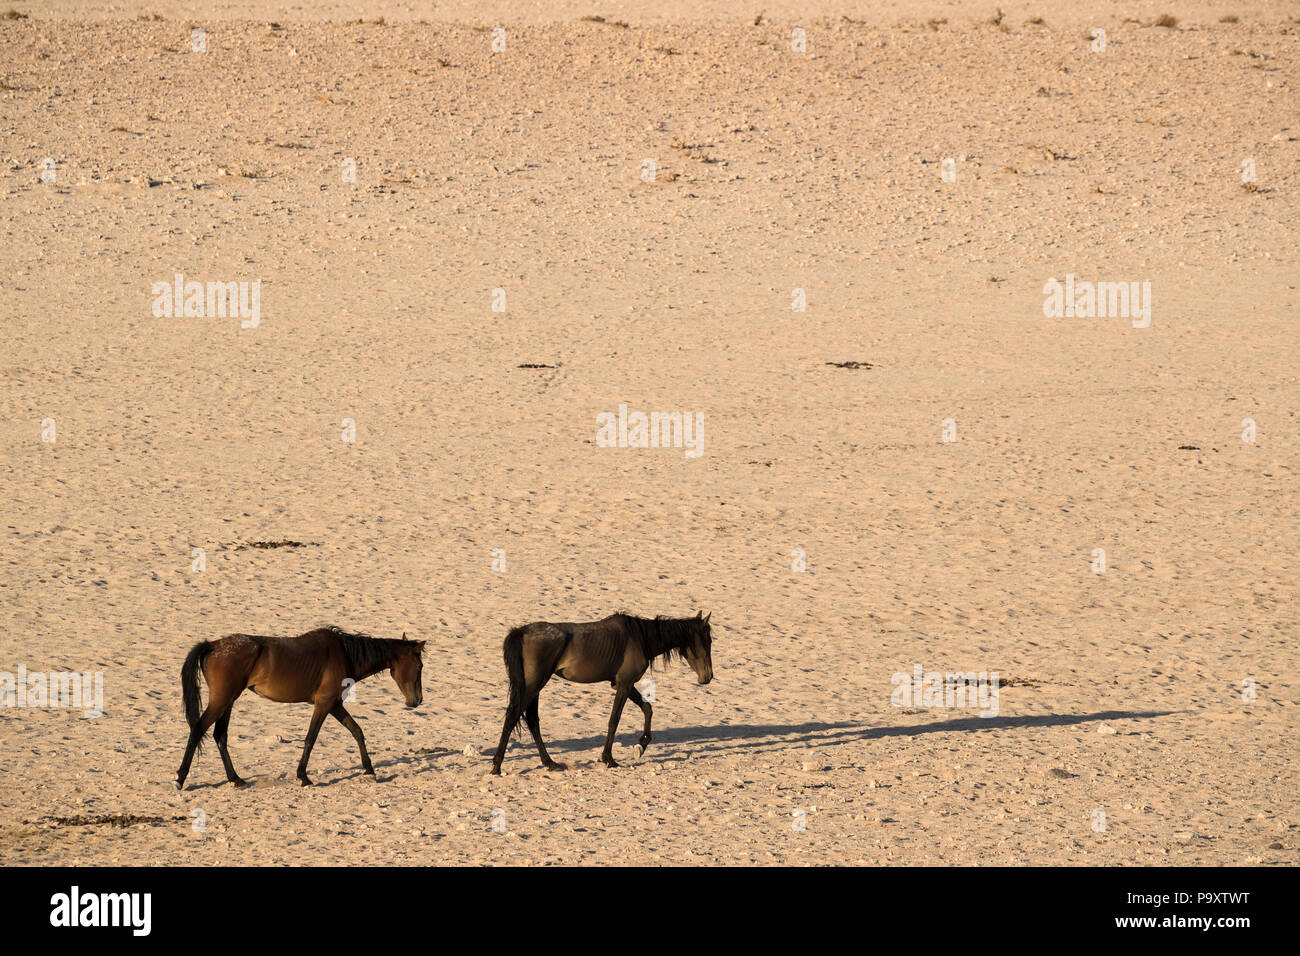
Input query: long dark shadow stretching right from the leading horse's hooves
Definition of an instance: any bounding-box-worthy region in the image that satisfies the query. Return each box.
[533,710,1180,756]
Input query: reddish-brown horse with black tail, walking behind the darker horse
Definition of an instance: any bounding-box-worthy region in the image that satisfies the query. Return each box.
[176,627,424,790]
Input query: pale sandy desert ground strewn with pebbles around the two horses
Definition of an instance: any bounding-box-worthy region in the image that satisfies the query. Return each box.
[0,0,1300,865]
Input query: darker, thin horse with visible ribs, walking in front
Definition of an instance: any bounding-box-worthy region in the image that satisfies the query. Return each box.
[491,614,714,774]
